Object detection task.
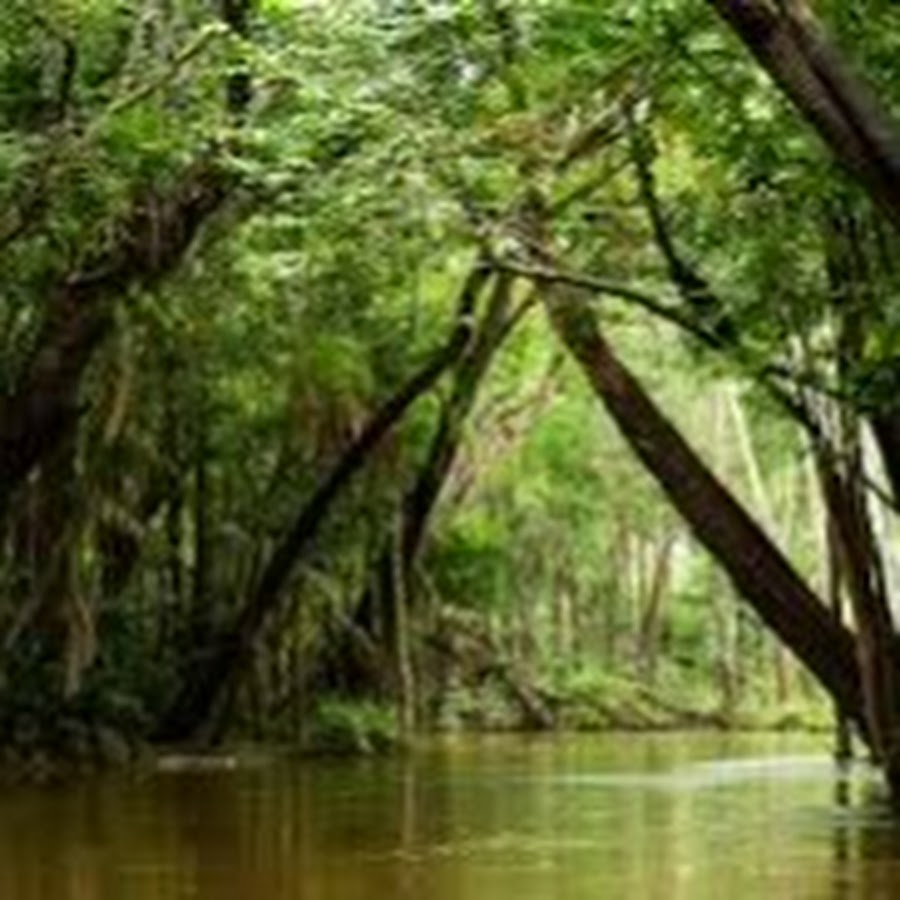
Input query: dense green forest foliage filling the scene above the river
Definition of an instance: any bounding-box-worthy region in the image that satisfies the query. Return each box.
[0,0,900,788]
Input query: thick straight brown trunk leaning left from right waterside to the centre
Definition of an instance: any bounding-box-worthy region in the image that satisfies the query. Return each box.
[523,192,868,737]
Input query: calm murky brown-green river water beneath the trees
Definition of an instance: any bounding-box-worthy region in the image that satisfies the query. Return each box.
[0,734,900,900]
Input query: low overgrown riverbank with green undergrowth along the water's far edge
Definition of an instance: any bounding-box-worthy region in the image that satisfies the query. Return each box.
[0,671,834,781]
